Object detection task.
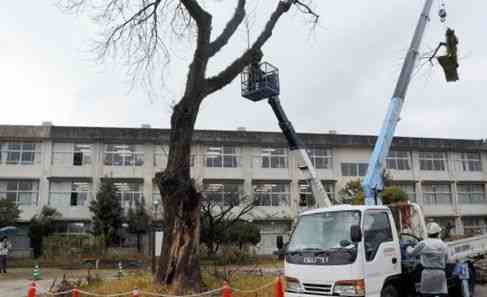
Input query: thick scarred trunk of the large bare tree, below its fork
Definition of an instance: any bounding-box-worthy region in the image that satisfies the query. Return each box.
[155,97,202,295]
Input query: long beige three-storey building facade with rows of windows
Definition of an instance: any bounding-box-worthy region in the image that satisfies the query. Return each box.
[0,125,487,254]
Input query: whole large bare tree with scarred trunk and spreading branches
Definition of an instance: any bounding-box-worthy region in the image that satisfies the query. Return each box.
[62,0,318,293]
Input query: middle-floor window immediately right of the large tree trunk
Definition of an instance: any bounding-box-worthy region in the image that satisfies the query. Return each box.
[203,182,243,206]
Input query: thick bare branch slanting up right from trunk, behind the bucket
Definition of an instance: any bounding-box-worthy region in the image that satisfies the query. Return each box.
[207,0,293,95]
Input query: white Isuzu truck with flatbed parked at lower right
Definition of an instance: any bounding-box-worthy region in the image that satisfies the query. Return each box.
[278,203,487,297]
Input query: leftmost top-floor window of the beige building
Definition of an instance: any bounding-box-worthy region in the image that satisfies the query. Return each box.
[0,142,36,165]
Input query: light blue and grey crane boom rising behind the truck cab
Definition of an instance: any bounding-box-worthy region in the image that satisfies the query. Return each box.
[362,0,433,205]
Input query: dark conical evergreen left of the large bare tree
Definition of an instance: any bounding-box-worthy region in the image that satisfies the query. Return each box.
[90,179,123,247]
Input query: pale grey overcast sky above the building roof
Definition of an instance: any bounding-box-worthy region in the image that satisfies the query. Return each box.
[0,0,487,138]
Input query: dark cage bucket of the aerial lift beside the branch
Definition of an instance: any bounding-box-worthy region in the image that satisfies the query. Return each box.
[241,62,280,102]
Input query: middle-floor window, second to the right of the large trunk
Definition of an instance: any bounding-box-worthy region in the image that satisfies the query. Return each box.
[253,183,289,206]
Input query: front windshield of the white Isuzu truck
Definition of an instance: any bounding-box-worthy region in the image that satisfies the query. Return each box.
[287,211,360,264]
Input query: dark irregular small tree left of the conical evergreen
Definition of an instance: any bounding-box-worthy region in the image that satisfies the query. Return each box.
[29,206,62,258]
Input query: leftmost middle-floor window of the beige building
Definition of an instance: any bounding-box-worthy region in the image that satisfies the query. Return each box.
[0,180,39,206]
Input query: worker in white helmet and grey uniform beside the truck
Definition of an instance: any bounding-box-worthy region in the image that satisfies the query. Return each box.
[407,223,449,297]
